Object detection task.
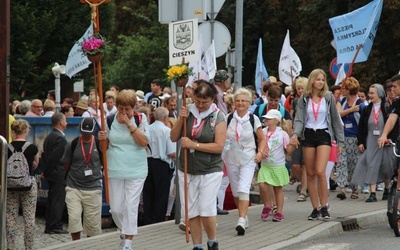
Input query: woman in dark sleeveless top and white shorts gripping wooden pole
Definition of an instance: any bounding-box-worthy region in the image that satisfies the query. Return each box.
[171,80,226,249]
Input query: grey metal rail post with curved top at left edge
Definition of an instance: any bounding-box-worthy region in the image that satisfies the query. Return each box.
[0,136,8,249]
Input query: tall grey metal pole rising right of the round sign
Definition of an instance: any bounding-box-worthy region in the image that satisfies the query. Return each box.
[235,0,243,88]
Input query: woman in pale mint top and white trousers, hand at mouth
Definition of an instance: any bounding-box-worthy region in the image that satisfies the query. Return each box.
[99,90,150,250]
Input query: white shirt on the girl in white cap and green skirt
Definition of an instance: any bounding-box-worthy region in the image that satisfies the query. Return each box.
[261,127,290,167]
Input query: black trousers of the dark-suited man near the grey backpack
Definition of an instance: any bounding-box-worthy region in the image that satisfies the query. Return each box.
[46,181,65,230]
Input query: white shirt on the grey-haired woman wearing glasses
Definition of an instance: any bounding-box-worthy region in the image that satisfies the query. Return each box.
[224,114,261,166]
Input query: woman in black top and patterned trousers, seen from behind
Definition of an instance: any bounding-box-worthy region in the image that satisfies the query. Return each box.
[6,119,39,249]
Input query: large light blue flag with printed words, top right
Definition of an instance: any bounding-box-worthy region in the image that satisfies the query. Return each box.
[329,0,383,64]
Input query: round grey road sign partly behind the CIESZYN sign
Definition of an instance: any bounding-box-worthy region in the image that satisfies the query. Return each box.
[199,21,231,57]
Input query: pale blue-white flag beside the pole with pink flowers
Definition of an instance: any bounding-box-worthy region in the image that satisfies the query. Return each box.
[65,22,93,78]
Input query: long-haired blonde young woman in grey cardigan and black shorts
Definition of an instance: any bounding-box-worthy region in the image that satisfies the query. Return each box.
[291,69,344,220]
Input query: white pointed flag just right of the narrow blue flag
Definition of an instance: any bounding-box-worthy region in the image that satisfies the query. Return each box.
[279,30,302,86]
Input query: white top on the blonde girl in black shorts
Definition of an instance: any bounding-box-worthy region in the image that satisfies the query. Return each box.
[306,97,328,129]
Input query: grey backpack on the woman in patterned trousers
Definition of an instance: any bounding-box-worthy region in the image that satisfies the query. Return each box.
[7,142,32,191]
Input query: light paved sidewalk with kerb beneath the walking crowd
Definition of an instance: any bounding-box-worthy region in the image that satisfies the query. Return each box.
[41,185,387,250]
